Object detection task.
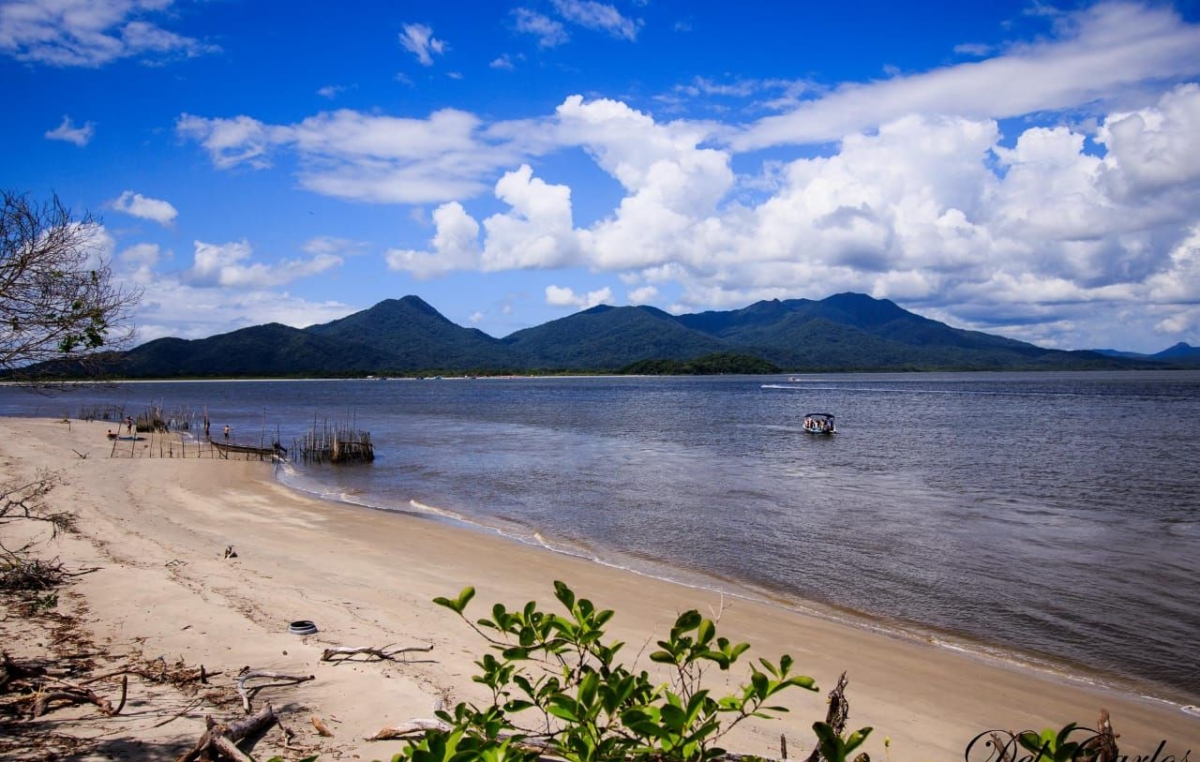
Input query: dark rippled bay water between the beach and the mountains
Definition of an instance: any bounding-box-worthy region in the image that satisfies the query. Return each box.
[0,372,1200,703]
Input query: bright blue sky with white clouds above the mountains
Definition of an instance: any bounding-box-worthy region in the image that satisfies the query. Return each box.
[0,0,1200,352]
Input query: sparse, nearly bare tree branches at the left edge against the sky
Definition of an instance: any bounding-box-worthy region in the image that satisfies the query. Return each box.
[0,191,142,378]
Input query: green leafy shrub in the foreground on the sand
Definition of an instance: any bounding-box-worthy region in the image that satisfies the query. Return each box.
[384,582,870,762]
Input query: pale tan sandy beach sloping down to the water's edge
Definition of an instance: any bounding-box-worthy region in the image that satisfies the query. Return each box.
[0,419,1200,762]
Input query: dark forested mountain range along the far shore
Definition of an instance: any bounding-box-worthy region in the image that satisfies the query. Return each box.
[88,293,1198,378]
